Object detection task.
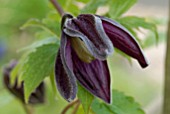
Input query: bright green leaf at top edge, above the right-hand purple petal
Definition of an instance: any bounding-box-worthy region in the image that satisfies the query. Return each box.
[109,0,137,18]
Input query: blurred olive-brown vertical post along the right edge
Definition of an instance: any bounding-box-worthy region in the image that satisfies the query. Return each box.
[163,2,170,114]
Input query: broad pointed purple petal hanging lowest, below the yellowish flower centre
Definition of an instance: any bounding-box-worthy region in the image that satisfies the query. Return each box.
[72,51,111,103]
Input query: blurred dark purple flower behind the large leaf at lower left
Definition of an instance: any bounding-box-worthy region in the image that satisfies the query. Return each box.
[3,61,45,104]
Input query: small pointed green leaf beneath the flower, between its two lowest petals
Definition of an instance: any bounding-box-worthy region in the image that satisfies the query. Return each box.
[77,84,94,114]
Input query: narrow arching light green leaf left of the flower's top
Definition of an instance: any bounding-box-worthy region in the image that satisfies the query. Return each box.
[20,19,56,36]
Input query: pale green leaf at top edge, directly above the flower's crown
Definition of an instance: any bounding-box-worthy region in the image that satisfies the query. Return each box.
[80,0,109,14]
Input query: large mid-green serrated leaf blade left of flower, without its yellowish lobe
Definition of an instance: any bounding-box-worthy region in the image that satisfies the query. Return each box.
[21,44,59,102]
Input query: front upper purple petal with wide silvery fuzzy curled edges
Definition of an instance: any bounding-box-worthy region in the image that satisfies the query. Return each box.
[64,14,113,60]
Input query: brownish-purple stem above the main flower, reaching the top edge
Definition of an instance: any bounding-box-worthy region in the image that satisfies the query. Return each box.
[50,0,65,16]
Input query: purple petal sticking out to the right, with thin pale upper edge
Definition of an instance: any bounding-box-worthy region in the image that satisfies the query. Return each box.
[100,17,148,68]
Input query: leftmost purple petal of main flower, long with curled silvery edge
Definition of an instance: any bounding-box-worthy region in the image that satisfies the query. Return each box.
[55,33,77,102]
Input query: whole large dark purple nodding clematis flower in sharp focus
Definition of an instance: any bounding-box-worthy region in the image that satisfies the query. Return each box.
[55,14,148,103]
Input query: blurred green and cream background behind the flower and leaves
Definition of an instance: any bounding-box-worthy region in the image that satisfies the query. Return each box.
[0,0,168,114]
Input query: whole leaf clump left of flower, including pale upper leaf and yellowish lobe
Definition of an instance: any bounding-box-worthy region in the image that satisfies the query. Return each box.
[11,38,59,101]
